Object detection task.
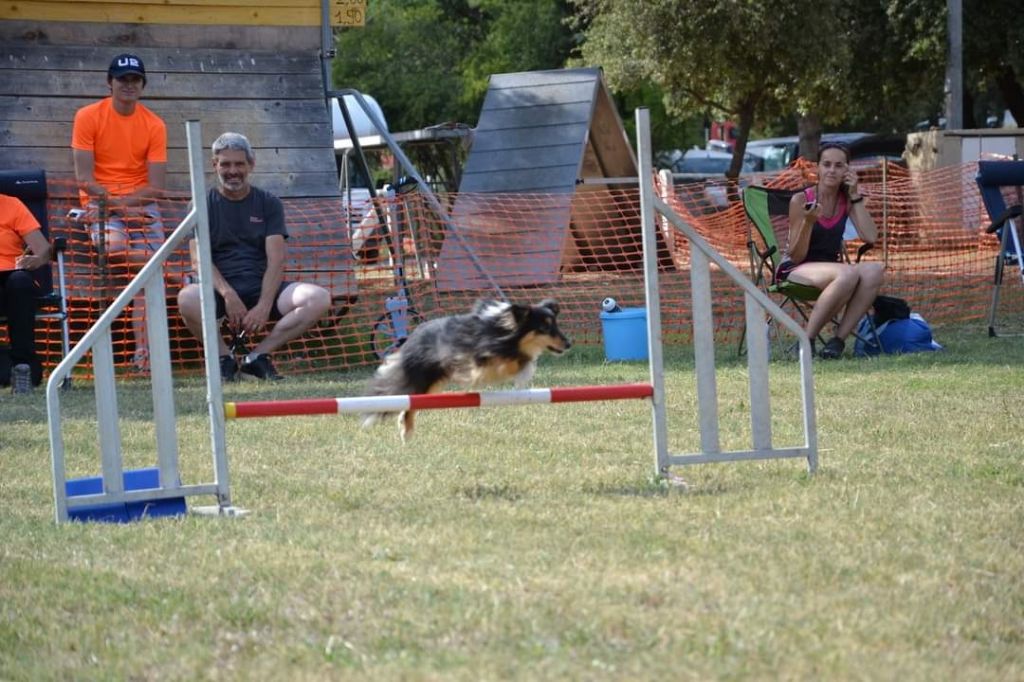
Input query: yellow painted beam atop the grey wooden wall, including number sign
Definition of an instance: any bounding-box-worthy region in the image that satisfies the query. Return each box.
[0,0,366,26]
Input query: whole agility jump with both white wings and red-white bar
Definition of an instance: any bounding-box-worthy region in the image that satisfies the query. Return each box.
[46,109,818,522]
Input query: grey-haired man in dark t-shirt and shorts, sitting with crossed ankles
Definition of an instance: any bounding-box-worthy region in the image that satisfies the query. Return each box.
[178,132,331,381]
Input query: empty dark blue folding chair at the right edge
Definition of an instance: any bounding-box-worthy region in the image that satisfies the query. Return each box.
[977,161,1024,336]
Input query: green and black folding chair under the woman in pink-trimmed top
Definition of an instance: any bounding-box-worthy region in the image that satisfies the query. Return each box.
[739,185,878,353]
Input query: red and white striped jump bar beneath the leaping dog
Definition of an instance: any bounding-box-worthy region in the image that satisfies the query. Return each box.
[224,384,654,419]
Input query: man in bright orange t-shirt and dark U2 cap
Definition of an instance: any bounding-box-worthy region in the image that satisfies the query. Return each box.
[71,54,167,370]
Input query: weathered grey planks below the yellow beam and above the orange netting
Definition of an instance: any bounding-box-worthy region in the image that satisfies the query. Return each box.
[0,14,338,198]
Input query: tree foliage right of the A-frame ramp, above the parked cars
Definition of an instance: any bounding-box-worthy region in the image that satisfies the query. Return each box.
[574,0,1024,156]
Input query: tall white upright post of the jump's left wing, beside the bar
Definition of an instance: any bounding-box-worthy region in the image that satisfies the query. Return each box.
[185,121,231,509]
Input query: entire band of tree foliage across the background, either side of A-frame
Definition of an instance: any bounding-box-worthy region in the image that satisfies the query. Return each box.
[334,0,1024,157]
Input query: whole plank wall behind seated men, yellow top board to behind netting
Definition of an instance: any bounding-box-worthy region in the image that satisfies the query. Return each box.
[0,9,356,300]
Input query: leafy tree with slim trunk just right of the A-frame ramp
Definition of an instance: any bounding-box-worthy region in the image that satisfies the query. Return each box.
[575,0,851,177]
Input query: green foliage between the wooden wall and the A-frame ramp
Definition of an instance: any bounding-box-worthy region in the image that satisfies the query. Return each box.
[333,0,573,130]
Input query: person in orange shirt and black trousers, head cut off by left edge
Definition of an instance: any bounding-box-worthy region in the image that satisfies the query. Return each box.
[0,195,50,393]
